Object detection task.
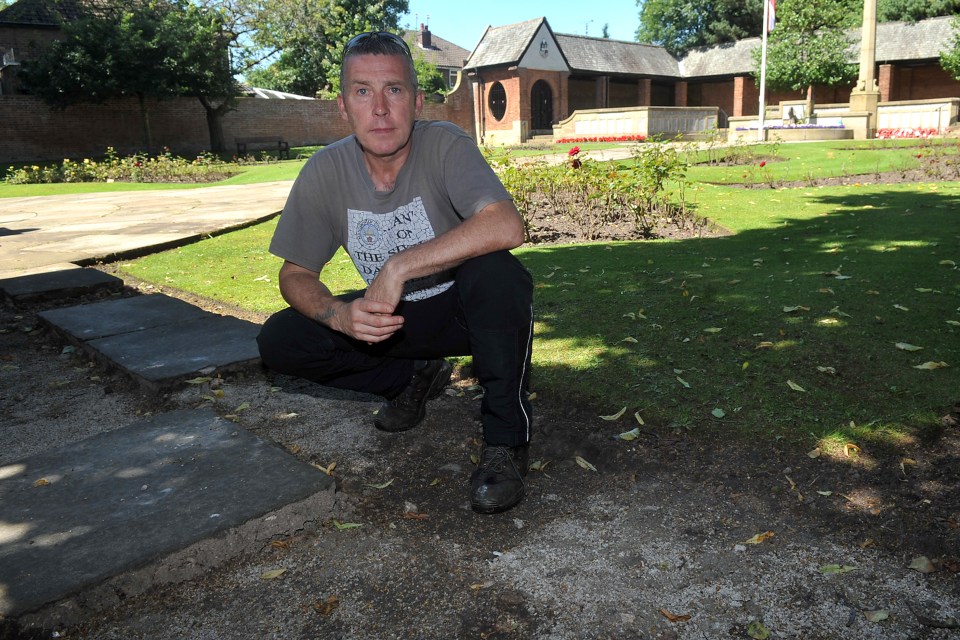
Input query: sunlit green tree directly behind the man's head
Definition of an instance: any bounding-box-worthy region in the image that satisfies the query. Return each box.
[247,0,409,96]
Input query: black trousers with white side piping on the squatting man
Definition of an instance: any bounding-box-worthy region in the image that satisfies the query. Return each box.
[257,251,533,446]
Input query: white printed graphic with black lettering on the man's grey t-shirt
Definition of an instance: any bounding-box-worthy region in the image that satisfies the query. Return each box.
[347,198,453,300]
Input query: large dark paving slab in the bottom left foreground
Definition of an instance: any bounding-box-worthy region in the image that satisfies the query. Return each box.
[0,409,334,624]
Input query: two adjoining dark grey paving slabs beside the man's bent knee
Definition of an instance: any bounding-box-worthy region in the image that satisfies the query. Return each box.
[39,294,260,388]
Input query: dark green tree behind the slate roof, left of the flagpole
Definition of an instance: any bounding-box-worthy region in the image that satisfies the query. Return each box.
[637,0,763,56]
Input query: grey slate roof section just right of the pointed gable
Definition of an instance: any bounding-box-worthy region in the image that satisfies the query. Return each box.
[554,33,680,77]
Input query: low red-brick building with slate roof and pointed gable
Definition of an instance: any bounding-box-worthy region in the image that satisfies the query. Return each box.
[464,16,960,143]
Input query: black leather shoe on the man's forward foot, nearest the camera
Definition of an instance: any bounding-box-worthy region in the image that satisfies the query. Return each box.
[470,444,530,513]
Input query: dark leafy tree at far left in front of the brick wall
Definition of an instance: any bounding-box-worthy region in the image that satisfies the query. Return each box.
[21,0,236,151]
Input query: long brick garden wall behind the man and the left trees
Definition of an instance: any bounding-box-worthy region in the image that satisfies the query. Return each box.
[0,83,473,164]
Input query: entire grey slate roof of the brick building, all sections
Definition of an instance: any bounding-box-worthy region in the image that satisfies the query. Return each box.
[466,16,954,79]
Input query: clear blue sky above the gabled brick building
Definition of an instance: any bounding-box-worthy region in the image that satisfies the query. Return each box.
[400,0,640,51]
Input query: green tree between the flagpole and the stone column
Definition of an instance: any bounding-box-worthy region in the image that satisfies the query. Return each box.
[754,0,863,118]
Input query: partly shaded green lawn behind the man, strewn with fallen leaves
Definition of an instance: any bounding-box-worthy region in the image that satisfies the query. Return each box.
[109,143,960,456]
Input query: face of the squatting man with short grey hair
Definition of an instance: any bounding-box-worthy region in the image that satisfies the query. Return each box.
[337,54,423,159]
